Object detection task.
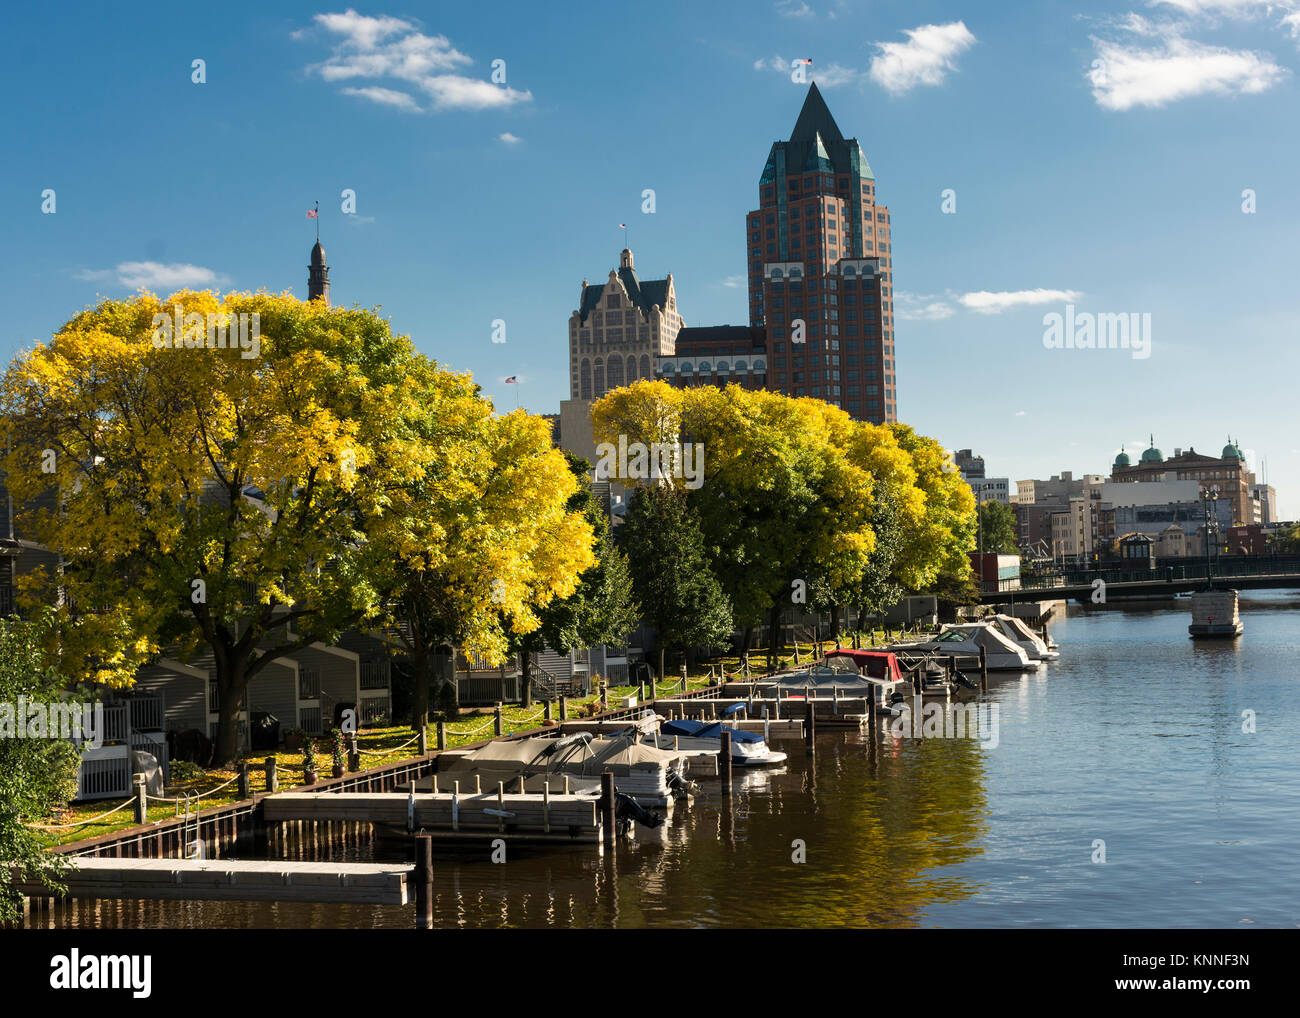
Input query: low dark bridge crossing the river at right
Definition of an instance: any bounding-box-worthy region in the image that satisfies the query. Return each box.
[980,555,1300,605]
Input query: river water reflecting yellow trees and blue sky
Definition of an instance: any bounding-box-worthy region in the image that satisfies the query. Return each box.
[30,592,1300,928]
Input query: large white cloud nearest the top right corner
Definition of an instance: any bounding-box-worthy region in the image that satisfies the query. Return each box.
[1088,26,1288,111]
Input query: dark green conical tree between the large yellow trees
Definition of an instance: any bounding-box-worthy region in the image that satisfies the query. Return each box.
[619,485,732,679]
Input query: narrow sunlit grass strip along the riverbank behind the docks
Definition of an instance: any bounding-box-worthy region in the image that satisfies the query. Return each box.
[32,632,904,845]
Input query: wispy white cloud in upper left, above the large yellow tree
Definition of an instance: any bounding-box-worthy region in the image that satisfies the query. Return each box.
[301,8,533,113]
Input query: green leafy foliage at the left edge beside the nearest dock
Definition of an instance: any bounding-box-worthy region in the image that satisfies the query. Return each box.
[0,612,79,926]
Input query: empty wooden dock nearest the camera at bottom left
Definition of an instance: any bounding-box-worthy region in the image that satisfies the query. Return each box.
[18,857,411,905]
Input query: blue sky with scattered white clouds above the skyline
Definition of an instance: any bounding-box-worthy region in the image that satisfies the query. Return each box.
[0,0,1300,519]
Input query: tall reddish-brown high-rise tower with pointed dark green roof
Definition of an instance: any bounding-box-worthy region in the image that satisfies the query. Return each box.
[746,85,898,423]
